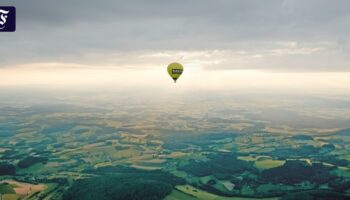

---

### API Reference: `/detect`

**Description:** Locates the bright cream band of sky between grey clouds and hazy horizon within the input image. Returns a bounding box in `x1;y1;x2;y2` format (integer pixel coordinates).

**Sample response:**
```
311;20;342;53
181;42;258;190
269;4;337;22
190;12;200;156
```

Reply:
0;58;350;94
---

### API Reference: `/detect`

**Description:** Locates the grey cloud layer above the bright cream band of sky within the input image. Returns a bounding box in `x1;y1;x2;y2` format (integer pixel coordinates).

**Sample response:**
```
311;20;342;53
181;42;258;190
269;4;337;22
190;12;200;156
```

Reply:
0;0;350;71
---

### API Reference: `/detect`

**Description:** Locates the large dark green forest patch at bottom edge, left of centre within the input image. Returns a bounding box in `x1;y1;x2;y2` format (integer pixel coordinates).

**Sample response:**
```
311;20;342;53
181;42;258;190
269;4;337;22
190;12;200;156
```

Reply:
63;166;185;200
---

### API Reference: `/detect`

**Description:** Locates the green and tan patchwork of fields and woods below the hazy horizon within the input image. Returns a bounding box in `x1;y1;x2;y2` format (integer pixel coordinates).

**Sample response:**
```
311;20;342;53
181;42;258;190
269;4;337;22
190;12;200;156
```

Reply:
0;93;350;200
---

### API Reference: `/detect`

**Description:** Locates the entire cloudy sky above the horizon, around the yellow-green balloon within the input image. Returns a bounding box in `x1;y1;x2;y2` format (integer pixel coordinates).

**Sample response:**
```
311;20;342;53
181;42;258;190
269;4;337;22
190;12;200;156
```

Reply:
0;0;350;93
